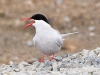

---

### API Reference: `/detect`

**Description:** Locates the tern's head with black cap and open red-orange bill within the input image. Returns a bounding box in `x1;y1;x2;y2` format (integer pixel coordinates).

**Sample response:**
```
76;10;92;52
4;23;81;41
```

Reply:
22;14;49;28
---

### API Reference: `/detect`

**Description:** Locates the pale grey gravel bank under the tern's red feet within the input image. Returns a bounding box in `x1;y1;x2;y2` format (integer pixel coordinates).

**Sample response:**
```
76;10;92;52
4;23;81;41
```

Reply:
0;47;100;75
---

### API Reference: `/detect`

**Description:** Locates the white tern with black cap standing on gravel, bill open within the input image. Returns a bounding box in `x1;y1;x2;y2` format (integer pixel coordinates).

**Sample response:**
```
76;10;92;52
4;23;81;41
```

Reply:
22;14;77;62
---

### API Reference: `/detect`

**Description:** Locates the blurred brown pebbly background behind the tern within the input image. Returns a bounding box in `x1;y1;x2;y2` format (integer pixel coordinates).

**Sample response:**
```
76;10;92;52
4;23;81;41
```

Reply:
0;0;100;64
